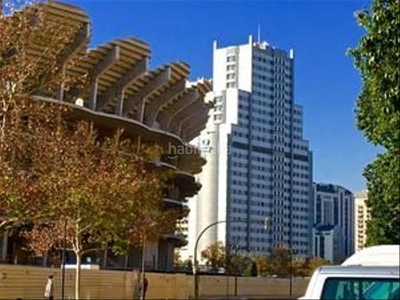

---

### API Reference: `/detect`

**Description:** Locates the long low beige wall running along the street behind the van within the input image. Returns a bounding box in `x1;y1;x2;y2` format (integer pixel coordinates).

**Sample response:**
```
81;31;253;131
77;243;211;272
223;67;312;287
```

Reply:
0;265;308;299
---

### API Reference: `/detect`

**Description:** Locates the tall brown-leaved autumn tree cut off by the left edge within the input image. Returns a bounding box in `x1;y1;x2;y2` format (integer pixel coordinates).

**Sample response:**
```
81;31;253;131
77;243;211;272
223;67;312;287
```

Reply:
0;0;83;237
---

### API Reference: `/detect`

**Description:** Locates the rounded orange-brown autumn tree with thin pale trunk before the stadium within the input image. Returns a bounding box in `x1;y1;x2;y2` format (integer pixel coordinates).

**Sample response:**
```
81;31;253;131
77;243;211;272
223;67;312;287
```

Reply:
24;119;171;299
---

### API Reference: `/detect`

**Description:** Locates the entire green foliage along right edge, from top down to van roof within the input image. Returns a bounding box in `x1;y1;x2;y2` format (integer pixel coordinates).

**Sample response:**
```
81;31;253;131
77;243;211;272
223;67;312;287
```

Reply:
350;0;400;245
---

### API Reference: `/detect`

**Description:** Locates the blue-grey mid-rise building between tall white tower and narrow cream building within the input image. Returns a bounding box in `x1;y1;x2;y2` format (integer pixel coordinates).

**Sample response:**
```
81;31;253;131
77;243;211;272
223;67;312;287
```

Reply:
313;183;354;262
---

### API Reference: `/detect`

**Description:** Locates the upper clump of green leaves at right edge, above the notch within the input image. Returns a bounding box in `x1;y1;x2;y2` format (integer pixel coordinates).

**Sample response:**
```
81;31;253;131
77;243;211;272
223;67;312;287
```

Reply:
350;0;400;149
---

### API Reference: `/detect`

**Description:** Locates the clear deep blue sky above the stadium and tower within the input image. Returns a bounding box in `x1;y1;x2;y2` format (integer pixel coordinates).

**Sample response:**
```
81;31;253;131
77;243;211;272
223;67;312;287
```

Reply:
68;0;378;191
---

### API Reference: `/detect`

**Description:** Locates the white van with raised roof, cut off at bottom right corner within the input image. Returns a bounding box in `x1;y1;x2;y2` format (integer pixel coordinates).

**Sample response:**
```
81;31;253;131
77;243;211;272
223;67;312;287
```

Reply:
300;245;400;300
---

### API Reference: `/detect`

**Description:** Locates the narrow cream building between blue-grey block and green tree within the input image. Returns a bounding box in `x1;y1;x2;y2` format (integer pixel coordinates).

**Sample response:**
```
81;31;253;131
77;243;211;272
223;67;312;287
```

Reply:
354;191;370;252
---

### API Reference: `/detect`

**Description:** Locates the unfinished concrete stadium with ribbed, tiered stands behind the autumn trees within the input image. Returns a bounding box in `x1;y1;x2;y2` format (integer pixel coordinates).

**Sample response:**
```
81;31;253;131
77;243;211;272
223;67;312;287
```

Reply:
0;2;211;270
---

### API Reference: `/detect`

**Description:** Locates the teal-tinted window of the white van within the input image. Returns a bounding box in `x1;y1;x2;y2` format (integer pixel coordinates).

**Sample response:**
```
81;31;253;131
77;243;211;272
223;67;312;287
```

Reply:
321;278;400;300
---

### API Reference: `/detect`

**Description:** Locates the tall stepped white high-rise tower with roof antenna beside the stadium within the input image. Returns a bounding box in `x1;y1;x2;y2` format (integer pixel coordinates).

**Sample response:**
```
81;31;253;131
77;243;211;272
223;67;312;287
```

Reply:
183;36;313;257
